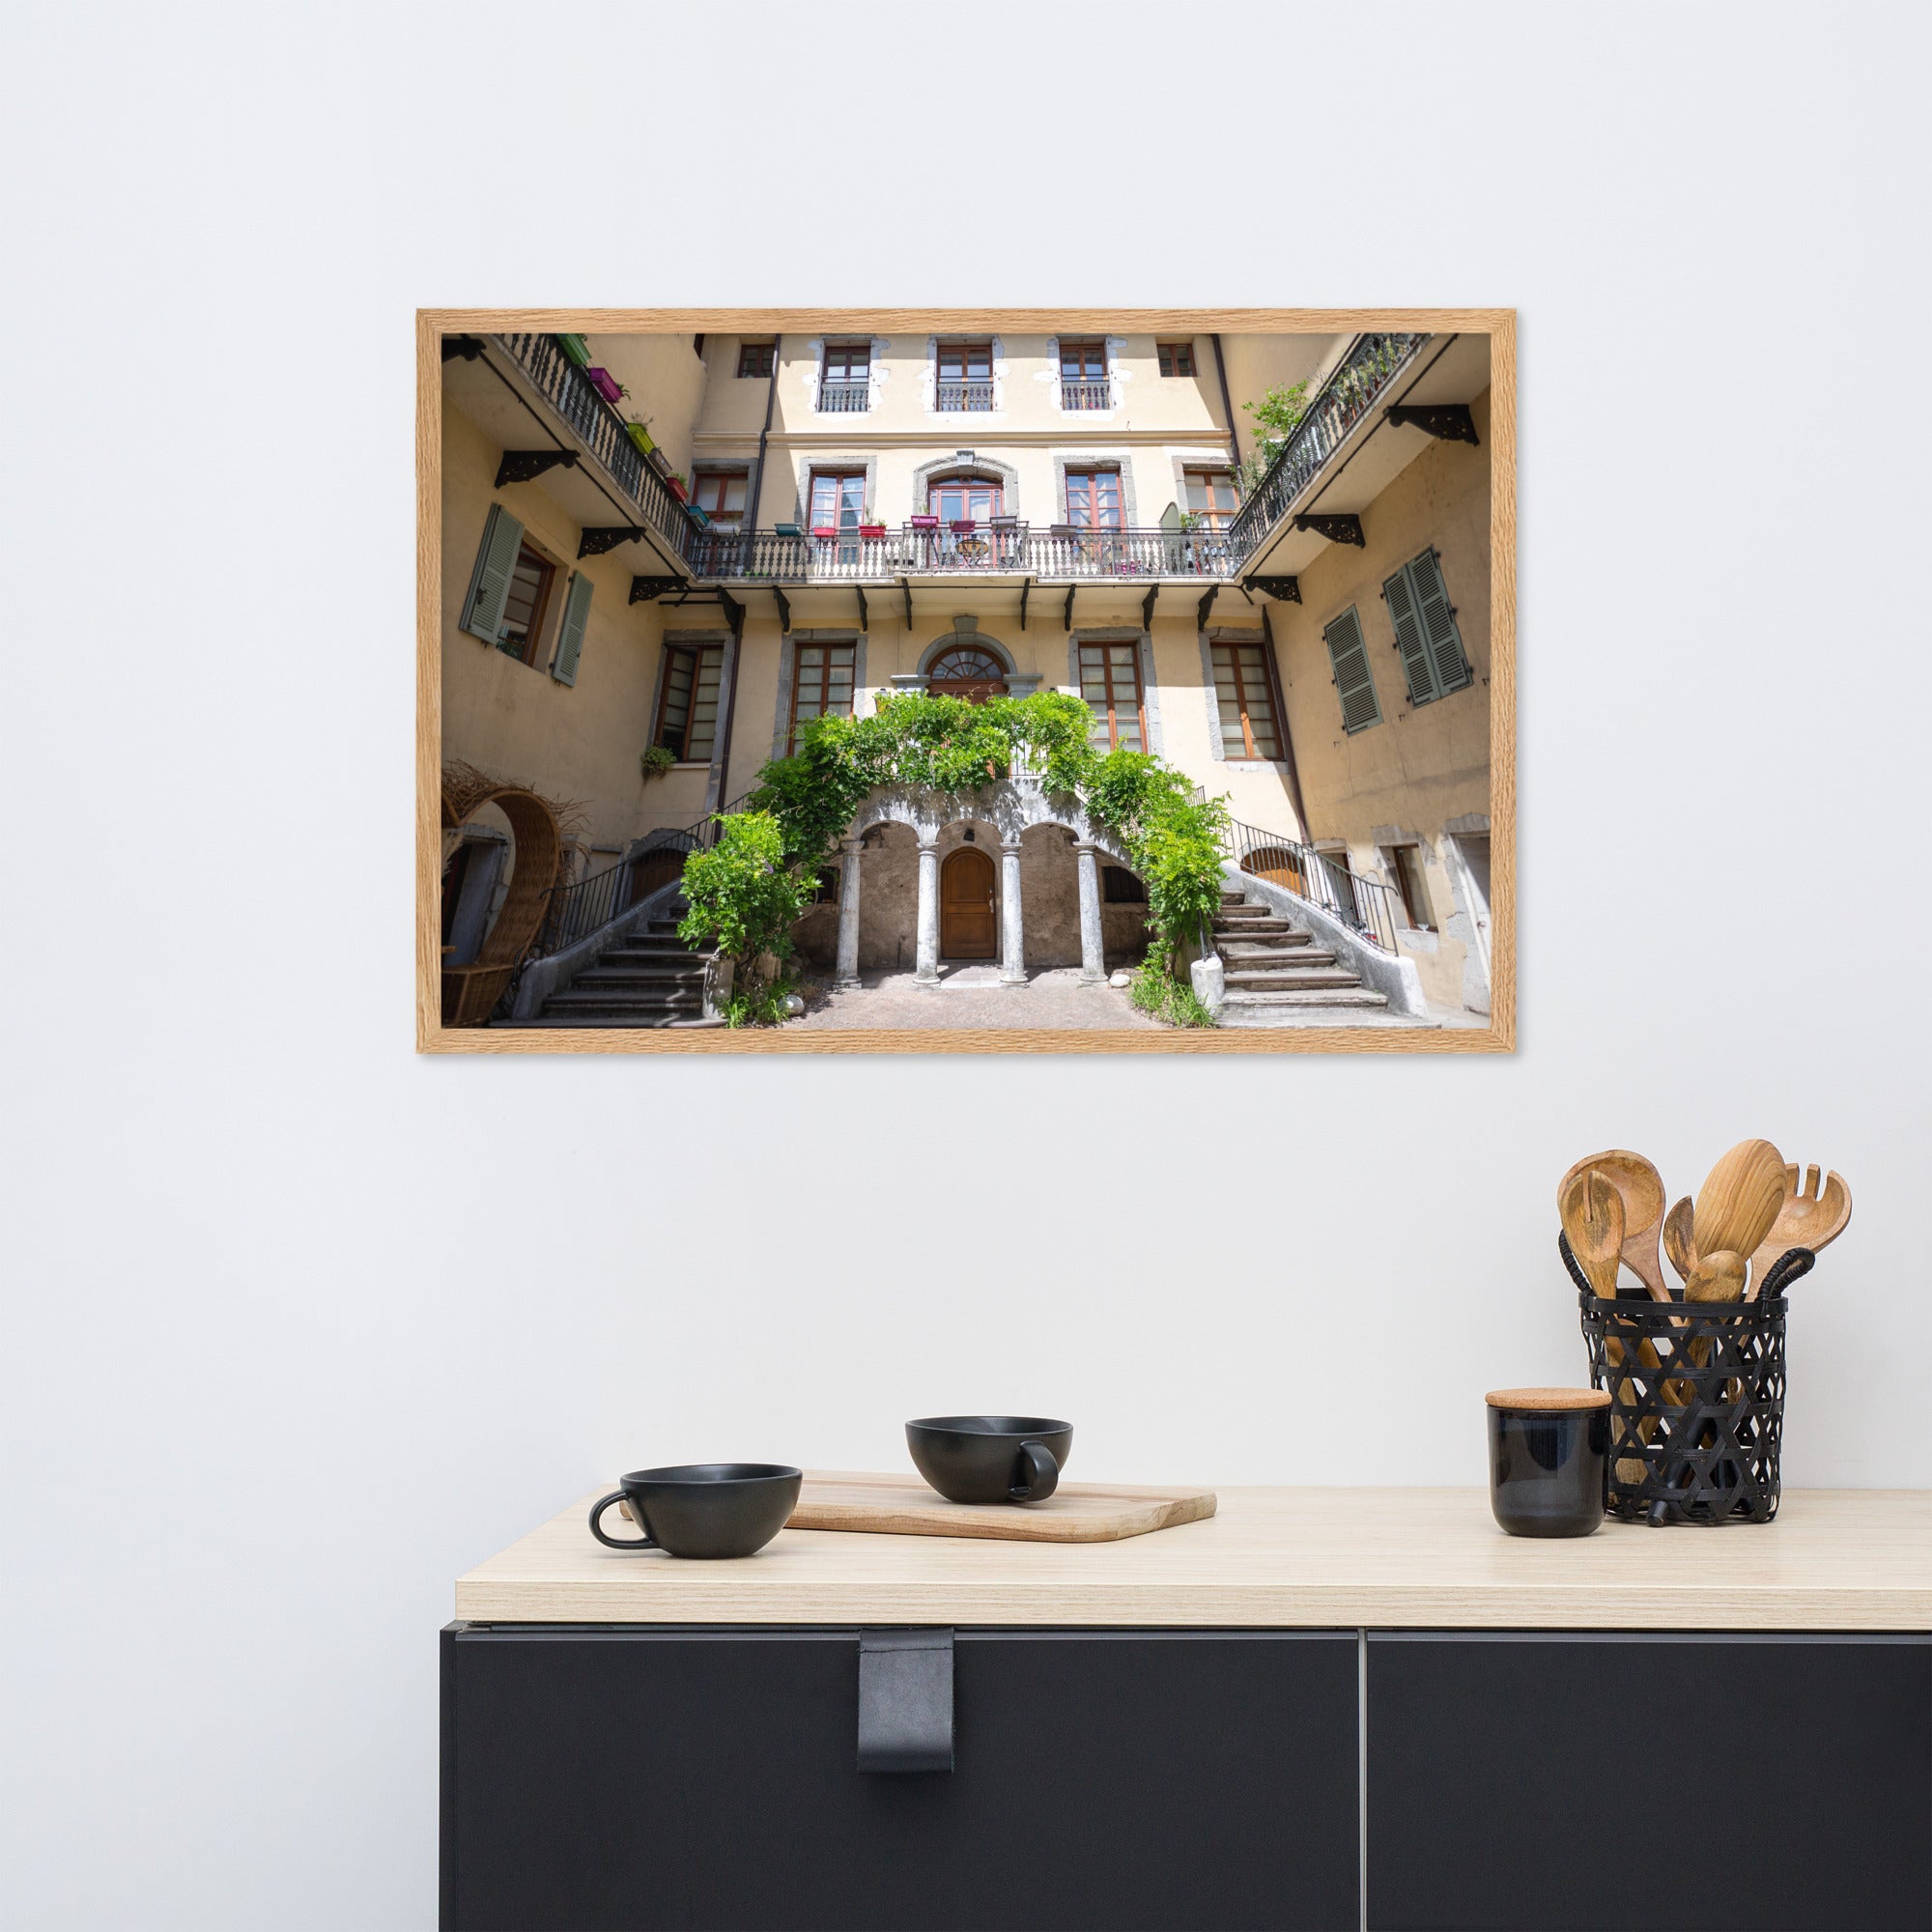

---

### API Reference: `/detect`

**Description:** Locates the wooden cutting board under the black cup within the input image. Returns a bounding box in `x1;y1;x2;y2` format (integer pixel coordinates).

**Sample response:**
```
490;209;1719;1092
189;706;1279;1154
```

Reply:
784;1470;1215;1544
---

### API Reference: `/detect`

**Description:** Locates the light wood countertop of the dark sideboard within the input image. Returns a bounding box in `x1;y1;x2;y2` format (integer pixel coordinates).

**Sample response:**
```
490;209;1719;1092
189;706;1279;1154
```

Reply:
456;1490;1932;1631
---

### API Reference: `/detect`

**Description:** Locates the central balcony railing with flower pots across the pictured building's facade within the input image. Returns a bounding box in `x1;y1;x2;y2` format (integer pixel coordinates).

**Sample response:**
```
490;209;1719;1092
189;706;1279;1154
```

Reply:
686;524;1246;585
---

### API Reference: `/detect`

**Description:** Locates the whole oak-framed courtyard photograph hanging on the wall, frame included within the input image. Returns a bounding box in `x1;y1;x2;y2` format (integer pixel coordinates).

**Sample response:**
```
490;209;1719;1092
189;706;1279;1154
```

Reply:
417;309;1515;1053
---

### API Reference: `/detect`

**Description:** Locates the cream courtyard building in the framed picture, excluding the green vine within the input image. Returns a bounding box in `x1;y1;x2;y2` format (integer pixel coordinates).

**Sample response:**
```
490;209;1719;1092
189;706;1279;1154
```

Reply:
440;325;1492;1028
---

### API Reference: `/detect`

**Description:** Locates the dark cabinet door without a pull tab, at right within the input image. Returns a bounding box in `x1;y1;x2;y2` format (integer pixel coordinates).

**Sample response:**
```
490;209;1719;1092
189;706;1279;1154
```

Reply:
1368;1631;1932;1932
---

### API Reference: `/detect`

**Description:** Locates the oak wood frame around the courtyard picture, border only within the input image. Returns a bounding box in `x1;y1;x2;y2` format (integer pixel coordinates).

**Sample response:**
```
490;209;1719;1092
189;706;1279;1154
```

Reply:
415;309;1517;1055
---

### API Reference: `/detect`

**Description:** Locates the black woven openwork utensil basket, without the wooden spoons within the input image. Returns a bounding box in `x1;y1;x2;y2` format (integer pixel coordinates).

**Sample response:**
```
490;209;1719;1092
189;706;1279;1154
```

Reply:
1557;1235;1816;1524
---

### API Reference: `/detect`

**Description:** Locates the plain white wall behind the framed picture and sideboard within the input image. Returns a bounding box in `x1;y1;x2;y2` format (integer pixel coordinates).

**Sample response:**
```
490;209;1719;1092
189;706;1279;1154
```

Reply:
11;0;1932;1932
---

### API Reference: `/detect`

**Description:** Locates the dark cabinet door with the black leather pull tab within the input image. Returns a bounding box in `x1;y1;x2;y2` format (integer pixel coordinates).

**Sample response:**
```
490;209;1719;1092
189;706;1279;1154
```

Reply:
442;1625;1360;1932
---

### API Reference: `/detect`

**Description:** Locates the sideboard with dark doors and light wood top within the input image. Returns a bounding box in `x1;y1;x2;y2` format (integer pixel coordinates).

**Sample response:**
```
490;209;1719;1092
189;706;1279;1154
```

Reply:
442;1490;1932;1932
